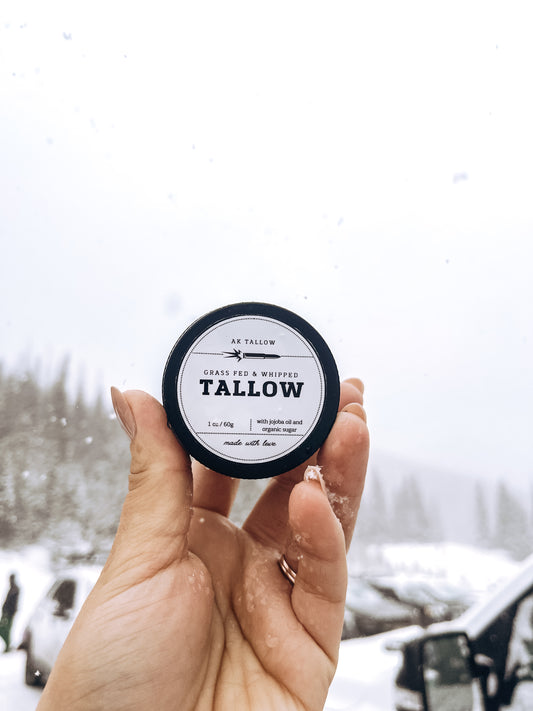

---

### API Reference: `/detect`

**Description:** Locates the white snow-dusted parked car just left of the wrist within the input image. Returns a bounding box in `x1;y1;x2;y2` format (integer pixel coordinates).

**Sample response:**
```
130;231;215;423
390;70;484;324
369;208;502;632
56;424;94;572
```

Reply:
21;566;100;686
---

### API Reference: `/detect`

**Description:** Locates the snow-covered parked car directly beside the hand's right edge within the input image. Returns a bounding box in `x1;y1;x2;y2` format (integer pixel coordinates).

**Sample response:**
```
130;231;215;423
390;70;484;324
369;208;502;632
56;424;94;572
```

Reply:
342;577;417;639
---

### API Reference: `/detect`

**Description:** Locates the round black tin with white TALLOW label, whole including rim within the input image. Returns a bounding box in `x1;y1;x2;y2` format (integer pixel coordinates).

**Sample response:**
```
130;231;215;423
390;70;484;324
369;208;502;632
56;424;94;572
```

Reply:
163;302;339;479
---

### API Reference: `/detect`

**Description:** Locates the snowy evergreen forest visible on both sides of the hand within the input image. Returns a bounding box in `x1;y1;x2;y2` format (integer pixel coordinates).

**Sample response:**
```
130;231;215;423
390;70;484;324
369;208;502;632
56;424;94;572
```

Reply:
0;360;533;559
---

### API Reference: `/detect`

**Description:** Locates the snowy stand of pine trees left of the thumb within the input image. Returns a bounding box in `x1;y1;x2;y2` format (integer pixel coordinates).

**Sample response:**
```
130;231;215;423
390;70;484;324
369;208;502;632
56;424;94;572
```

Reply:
0;360;129;547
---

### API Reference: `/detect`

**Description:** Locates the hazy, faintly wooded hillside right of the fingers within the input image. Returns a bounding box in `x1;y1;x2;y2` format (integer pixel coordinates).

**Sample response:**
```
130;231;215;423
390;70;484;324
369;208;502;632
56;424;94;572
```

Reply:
358;451;533;557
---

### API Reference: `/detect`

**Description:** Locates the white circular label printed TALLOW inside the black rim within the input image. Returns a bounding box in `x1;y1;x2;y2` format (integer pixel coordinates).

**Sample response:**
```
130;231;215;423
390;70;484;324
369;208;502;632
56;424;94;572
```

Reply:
176;316;325;464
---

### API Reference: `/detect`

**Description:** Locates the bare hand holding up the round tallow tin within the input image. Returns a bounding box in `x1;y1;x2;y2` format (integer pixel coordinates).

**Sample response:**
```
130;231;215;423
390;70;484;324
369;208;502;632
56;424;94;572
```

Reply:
38;379;368;711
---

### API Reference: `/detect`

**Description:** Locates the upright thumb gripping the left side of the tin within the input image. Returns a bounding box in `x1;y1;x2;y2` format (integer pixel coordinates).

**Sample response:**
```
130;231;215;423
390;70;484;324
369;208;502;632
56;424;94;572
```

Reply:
104;388;192;575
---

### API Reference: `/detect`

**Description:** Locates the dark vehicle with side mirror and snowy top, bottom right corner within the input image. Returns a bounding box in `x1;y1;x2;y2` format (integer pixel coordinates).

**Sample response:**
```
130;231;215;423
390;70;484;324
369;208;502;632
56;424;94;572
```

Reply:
395;556;533;711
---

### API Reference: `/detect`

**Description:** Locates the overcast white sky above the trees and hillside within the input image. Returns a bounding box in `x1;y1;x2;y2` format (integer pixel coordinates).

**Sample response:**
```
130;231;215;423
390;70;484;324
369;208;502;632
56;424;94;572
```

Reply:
0;0;533;485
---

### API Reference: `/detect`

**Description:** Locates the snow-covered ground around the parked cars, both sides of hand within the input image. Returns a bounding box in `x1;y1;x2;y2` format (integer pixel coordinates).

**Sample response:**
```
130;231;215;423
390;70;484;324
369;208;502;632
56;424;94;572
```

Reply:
0;544;518;711
